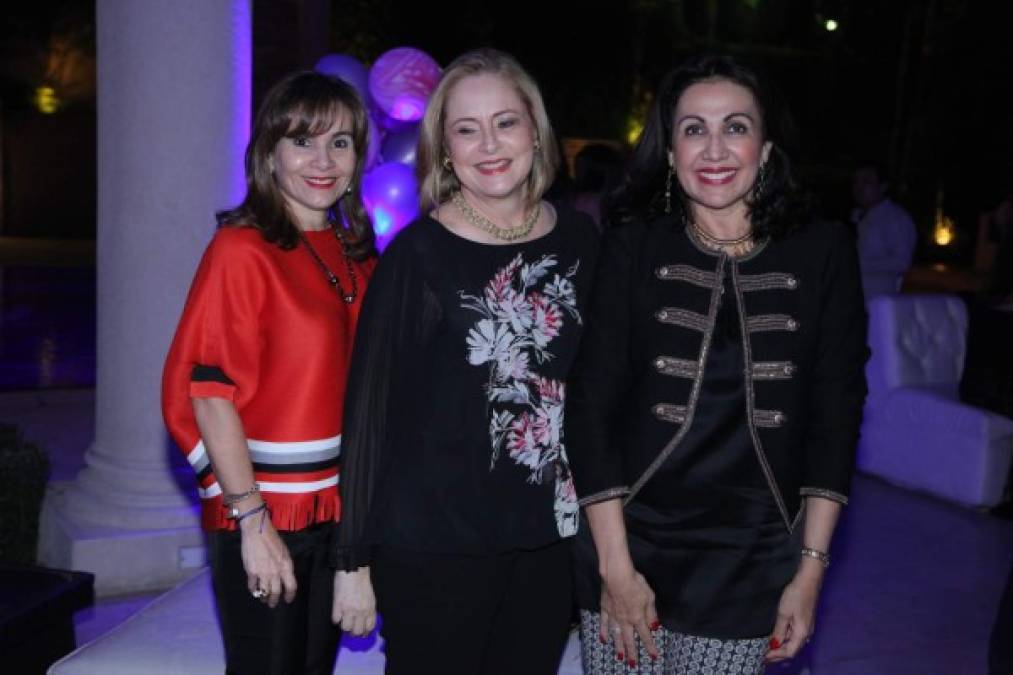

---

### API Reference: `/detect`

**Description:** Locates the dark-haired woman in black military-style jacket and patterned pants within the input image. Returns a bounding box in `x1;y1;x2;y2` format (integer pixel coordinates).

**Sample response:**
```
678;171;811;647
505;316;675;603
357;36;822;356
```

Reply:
566;56;867;674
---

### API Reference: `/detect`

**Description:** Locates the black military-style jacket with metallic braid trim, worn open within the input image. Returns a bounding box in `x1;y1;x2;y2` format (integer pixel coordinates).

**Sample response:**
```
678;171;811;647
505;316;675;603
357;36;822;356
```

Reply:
565;217;868;530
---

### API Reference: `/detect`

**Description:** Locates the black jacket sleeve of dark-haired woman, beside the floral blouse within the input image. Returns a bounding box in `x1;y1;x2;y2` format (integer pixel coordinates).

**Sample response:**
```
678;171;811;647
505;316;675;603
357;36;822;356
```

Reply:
565;226;633;506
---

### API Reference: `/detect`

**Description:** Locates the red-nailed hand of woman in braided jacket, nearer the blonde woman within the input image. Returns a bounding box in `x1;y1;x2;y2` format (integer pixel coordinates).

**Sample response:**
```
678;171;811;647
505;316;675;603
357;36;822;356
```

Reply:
602;564;660;666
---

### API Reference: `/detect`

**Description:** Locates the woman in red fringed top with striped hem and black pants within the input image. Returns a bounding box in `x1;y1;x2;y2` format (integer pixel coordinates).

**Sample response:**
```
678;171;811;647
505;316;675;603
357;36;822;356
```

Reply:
162;72;375;674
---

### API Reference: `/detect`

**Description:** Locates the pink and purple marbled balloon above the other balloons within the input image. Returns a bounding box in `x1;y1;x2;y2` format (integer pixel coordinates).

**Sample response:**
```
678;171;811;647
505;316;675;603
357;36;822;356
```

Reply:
370;47;440;122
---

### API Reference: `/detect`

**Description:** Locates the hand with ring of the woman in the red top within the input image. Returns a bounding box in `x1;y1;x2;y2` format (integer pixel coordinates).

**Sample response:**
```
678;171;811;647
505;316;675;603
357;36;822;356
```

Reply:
239;512;296;607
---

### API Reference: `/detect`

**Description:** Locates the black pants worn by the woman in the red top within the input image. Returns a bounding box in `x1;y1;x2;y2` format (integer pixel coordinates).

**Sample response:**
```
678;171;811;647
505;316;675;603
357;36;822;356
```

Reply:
208;523;340;675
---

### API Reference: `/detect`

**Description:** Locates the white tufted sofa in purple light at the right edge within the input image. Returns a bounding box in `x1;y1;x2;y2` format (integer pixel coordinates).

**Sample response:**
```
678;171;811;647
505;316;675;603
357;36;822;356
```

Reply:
858;295;1013;508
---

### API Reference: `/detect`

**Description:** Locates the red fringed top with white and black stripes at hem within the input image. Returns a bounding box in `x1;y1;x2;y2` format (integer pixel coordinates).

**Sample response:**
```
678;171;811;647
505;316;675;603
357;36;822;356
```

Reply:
162;227;375;530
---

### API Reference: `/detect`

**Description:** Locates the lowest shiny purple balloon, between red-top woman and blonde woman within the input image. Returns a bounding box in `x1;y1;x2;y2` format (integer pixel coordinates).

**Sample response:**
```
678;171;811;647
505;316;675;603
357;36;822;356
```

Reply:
363;162;418;250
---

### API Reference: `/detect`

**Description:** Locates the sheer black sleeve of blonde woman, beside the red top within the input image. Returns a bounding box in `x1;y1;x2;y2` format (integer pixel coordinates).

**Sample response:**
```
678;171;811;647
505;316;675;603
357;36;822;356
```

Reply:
331;225;440;571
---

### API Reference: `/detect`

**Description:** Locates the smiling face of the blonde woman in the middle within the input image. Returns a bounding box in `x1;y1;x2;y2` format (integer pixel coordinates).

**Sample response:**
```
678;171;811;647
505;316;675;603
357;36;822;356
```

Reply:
444;73;535;202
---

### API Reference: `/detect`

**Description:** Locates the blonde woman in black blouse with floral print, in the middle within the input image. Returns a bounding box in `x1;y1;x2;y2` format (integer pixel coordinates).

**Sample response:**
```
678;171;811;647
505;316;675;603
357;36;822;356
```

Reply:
334;50;598;675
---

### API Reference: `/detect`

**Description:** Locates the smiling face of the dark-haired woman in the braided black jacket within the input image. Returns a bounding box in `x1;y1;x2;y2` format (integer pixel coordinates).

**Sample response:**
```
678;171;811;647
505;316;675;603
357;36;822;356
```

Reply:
669;80;771;217
